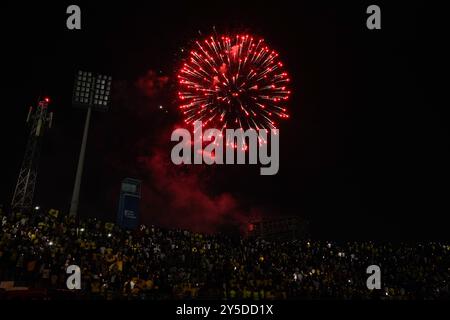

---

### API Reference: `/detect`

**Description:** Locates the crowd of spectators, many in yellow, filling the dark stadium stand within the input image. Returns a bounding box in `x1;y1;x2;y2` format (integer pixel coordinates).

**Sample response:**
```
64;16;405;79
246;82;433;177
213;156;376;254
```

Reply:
0;210;450;300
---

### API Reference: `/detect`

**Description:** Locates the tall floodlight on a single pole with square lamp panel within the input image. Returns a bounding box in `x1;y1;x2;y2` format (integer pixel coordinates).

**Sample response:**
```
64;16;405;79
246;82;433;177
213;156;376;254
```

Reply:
69;71;112;216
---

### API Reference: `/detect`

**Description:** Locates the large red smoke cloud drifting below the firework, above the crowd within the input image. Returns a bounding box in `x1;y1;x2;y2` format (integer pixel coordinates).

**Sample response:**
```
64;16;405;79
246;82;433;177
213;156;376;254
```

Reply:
138;145;246;232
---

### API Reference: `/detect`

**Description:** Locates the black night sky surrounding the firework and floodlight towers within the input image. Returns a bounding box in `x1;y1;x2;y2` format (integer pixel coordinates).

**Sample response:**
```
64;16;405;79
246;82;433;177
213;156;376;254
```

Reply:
0;1;450;239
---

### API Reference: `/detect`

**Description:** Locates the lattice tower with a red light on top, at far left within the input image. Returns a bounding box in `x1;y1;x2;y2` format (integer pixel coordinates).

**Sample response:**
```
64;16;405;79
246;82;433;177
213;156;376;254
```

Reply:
11;97;53;211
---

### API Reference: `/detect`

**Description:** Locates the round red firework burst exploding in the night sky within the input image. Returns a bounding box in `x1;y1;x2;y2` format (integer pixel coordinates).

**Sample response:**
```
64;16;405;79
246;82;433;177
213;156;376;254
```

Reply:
178;35;290;130
